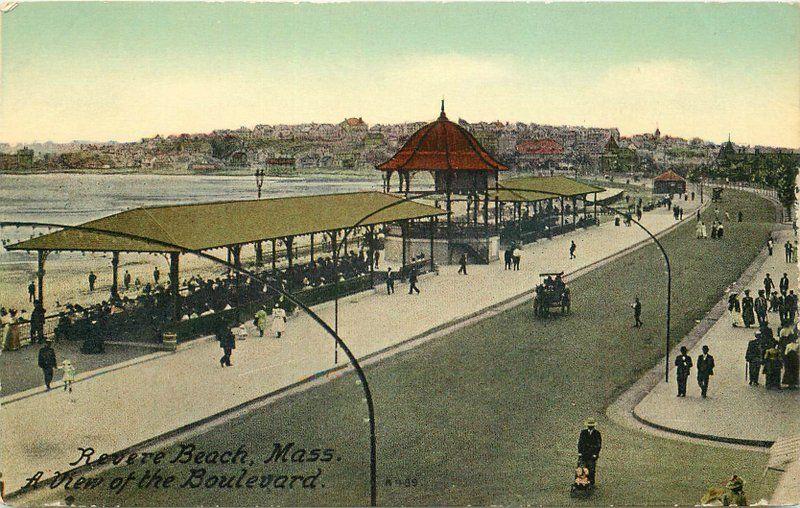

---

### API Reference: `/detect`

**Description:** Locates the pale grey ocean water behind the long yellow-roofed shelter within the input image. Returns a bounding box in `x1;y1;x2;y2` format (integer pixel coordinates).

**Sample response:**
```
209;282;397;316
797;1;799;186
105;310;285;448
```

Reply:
0;171;381;266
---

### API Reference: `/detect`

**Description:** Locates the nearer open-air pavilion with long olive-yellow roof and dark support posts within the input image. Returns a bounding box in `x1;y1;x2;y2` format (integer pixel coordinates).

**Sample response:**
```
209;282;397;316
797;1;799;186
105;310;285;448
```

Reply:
6;192;446;330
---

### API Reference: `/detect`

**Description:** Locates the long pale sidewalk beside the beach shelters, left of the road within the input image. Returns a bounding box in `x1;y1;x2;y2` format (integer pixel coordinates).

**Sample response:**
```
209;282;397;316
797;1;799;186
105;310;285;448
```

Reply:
2;193;699;492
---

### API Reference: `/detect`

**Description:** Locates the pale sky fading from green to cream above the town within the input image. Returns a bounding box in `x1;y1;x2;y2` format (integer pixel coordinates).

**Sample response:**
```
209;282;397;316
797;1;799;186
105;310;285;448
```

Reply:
0;2;800;148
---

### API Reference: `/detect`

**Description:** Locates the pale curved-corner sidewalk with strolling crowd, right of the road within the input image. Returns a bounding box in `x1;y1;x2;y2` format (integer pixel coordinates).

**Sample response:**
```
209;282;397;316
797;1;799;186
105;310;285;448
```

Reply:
633;229;800;446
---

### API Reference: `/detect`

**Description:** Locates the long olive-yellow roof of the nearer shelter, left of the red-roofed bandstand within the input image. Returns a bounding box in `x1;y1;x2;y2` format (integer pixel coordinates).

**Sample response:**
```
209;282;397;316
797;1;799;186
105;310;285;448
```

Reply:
6;191;446;252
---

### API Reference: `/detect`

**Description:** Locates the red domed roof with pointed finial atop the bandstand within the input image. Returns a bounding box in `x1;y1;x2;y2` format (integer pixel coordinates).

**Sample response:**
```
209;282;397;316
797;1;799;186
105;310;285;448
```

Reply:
377;101;508;171
